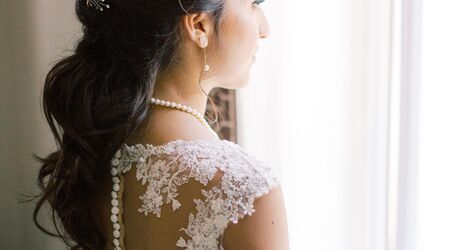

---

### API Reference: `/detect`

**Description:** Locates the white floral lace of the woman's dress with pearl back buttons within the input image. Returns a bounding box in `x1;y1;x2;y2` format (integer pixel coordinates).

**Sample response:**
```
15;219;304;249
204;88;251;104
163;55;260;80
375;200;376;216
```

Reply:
112;139;280;250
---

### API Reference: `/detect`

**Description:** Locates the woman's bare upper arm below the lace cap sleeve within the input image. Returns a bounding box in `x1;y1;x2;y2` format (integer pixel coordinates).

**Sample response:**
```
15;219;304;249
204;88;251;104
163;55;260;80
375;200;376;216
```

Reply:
224;185;289;250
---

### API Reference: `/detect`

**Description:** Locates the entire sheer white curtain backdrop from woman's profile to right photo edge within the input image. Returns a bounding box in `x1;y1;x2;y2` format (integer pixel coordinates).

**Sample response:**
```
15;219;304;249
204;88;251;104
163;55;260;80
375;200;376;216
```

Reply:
238;0;450;250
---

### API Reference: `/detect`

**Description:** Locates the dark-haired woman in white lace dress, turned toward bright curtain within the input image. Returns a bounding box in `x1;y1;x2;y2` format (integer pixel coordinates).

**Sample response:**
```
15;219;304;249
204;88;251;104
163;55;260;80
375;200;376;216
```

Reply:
34;0;288;250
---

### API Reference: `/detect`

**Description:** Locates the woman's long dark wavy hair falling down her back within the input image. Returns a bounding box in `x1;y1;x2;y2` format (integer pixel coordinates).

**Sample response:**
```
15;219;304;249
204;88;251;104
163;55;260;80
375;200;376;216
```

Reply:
22;0;224;250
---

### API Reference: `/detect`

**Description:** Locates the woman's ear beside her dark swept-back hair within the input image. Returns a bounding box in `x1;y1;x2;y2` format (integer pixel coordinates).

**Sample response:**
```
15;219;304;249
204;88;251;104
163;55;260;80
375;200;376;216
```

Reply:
181;13;213;47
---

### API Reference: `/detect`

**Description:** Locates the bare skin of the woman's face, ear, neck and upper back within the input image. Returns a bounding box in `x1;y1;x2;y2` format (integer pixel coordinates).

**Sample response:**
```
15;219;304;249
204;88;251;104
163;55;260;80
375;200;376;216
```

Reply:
127;0;270;145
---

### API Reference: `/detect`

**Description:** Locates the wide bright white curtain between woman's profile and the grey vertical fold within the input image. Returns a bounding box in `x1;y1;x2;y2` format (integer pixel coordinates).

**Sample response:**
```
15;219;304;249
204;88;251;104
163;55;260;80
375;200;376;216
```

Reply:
238;0;398;250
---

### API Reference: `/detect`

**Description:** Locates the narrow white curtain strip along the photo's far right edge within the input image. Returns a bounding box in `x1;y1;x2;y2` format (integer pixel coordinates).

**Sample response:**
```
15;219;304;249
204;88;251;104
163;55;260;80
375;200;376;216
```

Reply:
416;0;450;250
